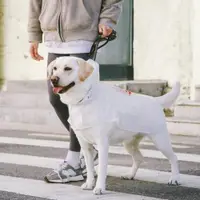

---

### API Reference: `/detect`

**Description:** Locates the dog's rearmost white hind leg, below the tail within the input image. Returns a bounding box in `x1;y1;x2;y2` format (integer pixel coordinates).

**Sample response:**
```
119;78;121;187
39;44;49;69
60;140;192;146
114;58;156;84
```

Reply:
150;128;180;185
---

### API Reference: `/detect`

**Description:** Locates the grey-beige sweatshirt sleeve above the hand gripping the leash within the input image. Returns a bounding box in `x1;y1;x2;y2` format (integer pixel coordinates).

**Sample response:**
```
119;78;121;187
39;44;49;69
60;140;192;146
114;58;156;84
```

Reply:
99;0;123;28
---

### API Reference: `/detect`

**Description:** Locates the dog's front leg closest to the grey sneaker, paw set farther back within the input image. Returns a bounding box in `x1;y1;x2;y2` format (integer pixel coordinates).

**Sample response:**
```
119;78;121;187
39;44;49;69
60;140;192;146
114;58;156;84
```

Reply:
78;138;95;190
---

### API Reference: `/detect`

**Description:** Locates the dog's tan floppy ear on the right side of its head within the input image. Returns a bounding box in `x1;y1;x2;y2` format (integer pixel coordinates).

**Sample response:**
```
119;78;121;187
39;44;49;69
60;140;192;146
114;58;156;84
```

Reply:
77;59;94;82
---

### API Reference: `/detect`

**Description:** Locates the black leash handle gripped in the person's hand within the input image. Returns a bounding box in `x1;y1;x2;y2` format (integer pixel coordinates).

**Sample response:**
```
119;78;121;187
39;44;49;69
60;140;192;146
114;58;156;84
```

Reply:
89;30;117;60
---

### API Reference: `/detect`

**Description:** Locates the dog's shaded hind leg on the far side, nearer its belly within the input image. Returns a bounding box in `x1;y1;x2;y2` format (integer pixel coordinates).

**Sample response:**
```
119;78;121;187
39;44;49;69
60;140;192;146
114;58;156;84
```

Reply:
122;135;143;180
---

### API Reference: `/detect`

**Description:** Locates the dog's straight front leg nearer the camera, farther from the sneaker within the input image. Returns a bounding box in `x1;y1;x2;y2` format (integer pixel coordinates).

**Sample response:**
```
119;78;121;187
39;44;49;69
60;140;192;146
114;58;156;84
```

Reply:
93;138;109;195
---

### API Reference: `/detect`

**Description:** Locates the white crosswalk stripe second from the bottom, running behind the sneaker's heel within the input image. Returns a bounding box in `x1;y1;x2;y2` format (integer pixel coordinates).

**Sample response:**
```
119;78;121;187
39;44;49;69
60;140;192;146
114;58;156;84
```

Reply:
0;153;200;189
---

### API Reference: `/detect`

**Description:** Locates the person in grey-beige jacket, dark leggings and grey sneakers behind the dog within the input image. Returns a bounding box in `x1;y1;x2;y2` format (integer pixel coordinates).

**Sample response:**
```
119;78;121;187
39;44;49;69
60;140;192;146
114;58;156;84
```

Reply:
28;0;123;183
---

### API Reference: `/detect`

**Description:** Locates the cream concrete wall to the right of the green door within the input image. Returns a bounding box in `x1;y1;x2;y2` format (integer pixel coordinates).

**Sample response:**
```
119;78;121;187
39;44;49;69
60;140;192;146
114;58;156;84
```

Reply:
134;0;200;98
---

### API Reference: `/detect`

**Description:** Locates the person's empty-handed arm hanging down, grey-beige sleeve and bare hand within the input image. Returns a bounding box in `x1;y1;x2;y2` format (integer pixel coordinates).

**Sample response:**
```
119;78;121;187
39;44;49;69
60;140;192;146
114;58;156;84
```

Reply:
28;0;44;61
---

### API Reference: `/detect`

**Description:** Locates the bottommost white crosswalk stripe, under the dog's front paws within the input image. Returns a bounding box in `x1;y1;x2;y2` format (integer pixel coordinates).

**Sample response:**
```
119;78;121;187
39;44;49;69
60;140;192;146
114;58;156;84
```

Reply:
0;176;166;200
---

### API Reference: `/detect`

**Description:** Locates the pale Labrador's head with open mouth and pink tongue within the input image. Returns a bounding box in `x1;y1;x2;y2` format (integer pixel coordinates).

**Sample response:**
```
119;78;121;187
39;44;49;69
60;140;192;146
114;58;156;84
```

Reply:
48;57;94;94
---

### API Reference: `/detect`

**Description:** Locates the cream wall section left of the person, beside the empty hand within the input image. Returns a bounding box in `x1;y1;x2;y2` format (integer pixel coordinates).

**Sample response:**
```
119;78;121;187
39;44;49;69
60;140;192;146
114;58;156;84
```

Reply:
4;0;46;80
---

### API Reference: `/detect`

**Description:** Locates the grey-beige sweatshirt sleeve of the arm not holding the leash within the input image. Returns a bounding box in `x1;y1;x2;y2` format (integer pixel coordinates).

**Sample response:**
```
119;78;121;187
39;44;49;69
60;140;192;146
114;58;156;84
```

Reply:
28;0;42;42
